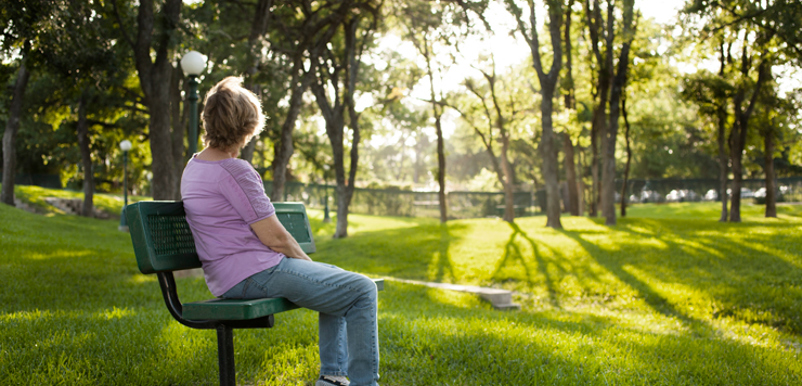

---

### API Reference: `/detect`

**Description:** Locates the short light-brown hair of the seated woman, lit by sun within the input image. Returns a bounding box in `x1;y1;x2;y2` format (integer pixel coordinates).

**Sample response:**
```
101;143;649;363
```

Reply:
201;76;265;151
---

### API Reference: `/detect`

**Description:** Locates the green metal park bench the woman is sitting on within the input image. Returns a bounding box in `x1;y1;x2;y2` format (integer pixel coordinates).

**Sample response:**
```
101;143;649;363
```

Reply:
125;201;384;386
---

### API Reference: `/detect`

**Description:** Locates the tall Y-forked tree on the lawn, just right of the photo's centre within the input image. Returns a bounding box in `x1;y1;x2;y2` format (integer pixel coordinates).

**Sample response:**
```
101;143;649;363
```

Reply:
506;0;563;229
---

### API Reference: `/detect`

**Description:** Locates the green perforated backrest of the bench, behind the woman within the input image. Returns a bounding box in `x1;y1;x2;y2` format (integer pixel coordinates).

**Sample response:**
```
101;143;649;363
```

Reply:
125;201;316;273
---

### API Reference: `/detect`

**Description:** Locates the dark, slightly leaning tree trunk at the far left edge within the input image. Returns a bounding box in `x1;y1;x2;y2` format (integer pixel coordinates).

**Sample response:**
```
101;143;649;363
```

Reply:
0;60;30;206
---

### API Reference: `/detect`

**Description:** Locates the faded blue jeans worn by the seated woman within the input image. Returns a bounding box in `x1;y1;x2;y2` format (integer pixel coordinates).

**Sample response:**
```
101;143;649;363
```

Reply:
223;257;379;386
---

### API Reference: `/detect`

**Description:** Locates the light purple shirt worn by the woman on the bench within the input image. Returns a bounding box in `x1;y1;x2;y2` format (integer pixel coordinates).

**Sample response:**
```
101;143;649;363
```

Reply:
181;158;284;296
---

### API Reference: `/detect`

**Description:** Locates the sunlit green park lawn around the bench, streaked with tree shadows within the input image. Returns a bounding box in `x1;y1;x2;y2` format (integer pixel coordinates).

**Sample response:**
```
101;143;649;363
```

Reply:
0;193;802;385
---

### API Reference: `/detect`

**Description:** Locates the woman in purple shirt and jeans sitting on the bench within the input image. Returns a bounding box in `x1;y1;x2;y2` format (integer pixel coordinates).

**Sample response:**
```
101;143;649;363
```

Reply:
181;77;379;386
